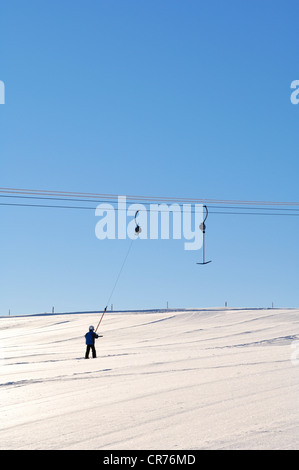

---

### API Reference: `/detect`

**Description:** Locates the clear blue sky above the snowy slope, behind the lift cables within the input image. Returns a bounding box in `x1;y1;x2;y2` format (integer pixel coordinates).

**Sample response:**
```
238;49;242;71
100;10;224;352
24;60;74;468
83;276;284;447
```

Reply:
0;0;299;314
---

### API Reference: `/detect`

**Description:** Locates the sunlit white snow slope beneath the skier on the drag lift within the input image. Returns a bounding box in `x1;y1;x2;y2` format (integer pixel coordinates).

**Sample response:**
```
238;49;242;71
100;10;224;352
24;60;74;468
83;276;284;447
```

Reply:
0;309;299;450
